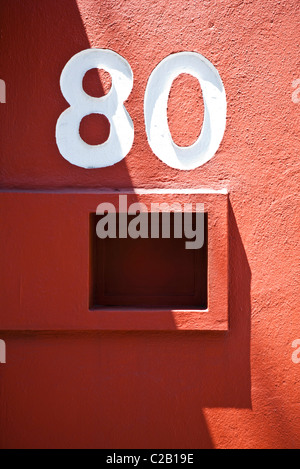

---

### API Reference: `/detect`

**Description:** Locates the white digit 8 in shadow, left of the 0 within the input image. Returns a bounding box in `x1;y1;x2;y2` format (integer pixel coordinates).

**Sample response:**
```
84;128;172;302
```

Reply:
56;49;134;168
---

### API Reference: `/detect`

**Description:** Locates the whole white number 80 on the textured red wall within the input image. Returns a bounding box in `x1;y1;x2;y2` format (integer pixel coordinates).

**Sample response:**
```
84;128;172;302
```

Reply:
56;49;227;170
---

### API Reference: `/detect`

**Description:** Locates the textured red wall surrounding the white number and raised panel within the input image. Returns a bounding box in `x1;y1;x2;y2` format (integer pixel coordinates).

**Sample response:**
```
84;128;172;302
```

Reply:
0;0;300;448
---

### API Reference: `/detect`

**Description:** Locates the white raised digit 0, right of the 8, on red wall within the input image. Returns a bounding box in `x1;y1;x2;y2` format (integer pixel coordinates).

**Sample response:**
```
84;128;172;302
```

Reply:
145;52;227;170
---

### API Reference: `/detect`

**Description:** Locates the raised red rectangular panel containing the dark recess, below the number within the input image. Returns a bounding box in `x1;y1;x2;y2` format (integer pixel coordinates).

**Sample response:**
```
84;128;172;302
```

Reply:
0;188;227;332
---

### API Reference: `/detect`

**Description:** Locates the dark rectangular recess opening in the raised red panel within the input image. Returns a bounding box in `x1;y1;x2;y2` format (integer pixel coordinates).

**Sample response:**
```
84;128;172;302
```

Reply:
90;213;208;308
